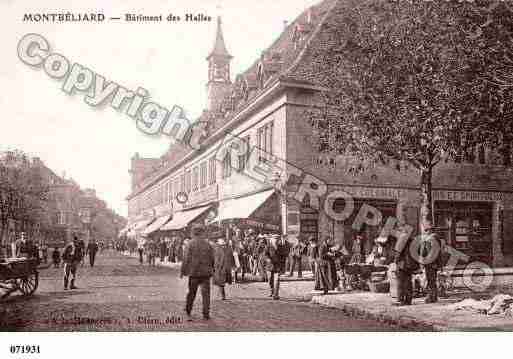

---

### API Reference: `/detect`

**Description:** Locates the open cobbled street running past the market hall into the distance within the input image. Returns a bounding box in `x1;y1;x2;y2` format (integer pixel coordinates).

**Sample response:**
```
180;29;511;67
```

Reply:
0;252;397;331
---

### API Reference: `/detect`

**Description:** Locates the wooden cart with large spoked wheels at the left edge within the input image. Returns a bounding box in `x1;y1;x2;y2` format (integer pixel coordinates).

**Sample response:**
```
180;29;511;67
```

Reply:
0;258;39;299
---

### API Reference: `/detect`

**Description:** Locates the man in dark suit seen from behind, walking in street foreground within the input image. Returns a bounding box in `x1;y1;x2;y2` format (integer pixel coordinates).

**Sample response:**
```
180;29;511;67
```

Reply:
180;225;214;320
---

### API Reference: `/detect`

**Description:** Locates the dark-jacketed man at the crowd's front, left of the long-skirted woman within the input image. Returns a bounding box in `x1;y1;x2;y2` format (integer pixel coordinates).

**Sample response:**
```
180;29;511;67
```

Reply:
267;235;290;300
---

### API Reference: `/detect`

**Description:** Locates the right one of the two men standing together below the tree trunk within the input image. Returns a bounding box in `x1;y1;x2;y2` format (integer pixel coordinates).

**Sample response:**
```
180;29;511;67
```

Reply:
420;222;442;303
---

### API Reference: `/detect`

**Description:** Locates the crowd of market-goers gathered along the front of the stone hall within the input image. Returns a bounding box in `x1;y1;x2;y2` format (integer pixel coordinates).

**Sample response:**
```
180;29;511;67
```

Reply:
176;224;442;318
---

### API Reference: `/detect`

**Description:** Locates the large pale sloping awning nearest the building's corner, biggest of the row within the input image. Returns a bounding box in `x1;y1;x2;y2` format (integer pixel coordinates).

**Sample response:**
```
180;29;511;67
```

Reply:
216;189;274;222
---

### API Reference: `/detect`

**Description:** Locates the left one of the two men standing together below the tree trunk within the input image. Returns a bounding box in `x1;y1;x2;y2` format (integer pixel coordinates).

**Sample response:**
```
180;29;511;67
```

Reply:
394;234;419;305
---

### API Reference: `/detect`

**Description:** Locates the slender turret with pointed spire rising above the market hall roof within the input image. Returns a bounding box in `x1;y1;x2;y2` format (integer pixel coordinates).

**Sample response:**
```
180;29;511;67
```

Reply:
207;17;233;111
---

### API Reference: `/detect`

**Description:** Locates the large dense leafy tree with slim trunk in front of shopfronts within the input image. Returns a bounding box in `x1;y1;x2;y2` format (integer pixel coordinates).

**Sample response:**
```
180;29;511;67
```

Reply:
311;0;513;233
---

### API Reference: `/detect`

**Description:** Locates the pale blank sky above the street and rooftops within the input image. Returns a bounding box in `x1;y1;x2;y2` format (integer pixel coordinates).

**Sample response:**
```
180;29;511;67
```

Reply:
0;0;319;216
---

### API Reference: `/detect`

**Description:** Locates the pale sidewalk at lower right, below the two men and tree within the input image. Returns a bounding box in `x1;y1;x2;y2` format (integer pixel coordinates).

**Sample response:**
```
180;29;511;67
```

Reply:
312;286;513;331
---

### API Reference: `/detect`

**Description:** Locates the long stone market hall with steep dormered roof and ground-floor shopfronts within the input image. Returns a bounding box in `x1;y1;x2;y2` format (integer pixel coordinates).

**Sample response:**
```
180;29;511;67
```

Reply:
128;0;513;266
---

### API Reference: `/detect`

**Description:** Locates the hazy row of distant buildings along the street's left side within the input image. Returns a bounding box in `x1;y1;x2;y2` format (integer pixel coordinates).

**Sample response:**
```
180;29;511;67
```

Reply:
1;157;126;247
